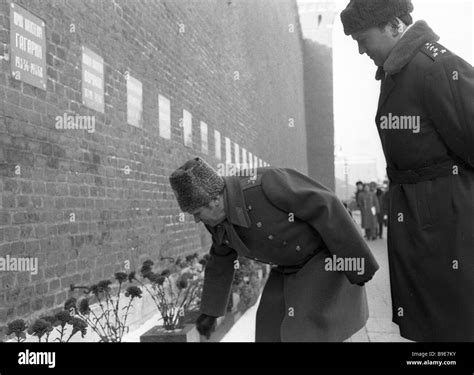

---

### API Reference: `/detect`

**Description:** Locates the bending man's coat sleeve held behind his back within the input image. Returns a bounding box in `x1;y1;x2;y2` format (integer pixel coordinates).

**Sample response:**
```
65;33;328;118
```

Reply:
262;168;379;284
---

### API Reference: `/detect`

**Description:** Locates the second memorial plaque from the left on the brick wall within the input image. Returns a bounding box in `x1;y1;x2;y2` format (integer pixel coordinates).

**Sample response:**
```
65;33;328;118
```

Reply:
82;47;104;113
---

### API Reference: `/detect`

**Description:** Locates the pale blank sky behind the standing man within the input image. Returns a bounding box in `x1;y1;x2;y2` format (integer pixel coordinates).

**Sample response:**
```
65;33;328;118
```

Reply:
298;0;474;180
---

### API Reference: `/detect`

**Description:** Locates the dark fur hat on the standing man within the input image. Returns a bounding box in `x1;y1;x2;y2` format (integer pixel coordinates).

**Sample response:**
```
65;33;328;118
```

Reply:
341;0;413;35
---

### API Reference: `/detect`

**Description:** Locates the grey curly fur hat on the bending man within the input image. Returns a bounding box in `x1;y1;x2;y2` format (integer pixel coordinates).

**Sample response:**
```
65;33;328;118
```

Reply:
169;157;225;212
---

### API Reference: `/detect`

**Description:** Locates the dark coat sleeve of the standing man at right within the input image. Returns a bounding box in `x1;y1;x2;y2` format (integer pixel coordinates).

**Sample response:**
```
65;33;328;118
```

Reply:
424;54;474;167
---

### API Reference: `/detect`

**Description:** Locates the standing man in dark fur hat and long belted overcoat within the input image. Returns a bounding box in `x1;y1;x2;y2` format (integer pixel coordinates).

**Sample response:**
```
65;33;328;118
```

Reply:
341;0;474;341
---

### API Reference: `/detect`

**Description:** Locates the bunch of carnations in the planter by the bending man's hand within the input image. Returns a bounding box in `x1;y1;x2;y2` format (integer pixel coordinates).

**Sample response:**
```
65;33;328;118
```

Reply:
133;254;207;331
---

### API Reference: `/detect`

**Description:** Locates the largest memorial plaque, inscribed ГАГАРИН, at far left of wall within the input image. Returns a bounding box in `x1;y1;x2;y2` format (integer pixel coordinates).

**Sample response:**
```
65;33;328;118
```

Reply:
10;4;47;90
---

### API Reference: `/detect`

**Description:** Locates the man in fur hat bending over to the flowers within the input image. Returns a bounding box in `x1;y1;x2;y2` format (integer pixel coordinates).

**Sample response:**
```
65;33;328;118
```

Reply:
170;158;378;342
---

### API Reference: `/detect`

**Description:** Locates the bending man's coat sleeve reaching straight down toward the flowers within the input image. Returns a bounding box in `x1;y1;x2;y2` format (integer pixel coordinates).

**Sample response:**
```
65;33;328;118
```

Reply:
200;227;237;317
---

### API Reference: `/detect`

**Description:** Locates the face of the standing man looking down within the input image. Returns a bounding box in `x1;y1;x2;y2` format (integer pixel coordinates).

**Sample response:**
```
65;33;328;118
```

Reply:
352;25;397;66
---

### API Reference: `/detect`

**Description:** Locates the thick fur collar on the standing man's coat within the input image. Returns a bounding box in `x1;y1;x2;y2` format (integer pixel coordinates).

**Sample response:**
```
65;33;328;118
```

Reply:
375;20;439;80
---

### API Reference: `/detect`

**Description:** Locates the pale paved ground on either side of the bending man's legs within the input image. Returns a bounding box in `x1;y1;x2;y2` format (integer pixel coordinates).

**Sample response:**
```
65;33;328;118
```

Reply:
221;231;408;342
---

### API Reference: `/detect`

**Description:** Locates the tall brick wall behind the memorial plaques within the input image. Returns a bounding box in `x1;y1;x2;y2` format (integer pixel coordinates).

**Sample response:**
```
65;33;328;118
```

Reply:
0;0;308;334
